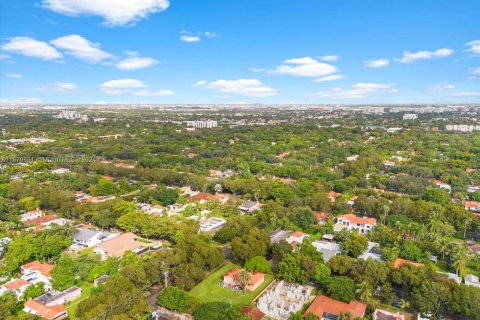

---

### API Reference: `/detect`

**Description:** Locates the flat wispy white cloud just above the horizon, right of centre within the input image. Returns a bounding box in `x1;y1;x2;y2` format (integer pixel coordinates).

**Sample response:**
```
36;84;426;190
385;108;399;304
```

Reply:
313;82;399;99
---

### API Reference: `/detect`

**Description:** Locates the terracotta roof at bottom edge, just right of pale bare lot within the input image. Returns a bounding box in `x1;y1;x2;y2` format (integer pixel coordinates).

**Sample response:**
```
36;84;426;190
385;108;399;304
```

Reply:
305;296;367;319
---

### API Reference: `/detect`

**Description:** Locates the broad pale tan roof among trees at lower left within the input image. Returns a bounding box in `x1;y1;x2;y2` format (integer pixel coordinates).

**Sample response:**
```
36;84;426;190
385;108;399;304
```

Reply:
94;232;145;259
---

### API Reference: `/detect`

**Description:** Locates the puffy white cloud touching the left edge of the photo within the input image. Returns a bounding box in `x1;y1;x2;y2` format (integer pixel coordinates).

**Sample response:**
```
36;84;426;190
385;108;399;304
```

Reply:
1;37;62;60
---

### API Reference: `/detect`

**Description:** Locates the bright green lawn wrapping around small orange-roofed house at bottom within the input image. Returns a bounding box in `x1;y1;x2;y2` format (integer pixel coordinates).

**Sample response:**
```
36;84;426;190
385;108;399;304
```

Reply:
189;263;274;306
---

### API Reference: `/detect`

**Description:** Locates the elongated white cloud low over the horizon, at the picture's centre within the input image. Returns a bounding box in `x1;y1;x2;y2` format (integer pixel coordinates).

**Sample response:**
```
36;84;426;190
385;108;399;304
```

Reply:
193;79;277;97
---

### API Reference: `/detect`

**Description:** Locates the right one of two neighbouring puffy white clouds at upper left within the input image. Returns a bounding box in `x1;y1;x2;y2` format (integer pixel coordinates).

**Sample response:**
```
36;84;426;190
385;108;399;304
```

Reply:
50;34;113;63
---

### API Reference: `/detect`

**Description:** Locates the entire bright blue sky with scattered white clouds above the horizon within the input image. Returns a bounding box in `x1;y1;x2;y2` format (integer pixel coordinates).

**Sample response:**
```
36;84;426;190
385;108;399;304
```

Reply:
0;0;480;104
